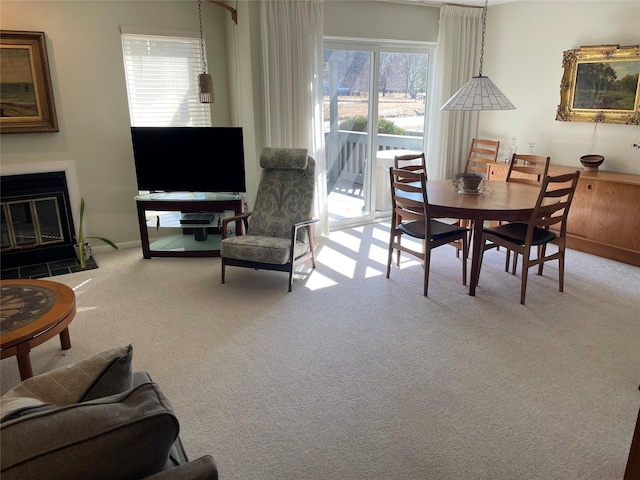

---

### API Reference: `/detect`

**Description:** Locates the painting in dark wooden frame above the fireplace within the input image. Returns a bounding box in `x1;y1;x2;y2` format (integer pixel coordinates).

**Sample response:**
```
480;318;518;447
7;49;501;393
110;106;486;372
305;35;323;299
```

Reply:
0;30;59;133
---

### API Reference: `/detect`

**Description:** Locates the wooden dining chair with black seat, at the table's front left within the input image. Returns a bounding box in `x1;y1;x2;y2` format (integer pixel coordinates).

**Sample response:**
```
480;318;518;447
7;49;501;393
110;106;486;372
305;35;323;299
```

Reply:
387;167;469;297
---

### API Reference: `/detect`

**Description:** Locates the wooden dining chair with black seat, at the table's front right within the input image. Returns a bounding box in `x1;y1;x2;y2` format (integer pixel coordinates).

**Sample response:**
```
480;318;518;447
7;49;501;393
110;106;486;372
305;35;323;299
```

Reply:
478;171;580;305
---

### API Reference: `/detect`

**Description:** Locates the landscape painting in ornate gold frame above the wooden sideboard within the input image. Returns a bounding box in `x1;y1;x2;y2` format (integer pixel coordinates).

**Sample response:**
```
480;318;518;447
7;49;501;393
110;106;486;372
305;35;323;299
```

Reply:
556;45;640;125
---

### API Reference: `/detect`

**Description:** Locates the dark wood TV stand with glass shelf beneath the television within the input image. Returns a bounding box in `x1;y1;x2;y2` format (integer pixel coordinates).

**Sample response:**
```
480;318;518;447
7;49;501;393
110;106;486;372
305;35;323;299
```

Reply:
135;192;245;258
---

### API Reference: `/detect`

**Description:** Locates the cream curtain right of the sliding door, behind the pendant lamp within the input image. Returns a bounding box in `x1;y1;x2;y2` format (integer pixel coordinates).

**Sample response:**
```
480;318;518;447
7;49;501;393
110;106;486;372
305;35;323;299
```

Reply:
427;5;482;179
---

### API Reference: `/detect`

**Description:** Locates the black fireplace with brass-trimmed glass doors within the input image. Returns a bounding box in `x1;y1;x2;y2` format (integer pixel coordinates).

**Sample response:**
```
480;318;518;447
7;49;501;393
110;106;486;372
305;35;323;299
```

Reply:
0;171;75;270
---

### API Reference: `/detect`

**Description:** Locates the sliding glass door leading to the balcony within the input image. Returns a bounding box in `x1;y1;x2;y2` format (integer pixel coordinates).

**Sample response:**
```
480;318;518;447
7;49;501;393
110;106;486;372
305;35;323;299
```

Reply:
323;41;430;228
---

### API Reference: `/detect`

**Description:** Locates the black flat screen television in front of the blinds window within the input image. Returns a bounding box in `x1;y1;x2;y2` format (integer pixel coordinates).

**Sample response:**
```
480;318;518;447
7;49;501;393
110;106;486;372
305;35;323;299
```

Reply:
131;127;246;193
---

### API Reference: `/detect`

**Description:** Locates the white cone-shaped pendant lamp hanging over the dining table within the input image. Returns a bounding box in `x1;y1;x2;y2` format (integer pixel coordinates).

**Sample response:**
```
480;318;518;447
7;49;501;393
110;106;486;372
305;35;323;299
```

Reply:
440;0;516;111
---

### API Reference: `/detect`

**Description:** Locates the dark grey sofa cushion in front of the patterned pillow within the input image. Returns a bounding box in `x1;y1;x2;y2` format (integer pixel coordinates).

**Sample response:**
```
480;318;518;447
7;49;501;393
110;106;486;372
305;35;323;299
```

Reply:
0;383;180;480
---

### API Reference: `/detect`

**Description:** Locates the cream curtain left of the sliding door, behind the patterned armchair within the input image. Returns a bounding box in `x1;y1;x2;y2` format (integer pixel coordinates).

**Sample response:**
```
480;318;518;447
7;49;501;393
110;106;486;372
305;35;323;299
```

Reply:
260;0;329;236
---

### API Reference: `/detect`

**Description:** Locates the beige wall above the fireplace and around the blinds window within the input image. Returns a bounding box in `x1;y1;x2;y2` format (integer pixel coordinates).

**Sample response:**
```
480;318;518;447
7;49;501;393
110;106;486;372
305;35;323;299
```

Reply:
0;0;231;248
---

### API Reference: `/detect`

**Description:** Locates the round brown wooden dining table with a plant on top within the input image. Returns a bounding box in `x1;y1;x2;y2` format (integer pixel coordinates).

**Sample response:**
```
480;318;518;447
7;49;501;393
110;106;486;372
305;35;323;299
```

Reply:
427;179;544;296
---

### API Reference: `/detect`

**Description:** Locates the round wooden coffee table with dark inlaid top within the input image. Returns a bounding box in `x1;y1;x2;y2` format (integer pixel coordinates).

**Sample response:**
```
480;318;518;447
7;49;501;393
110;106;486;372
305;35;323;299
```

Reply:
0;280;76;380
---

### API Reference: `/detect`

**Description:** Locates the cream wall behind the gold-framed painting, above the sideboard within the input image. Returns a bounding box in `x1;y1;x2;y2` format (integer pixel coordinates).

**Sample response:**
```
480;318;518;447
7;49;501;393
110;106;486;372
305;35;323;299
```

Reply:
480;0;640;174
